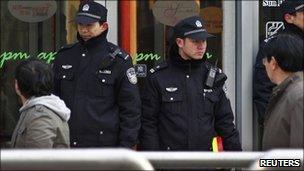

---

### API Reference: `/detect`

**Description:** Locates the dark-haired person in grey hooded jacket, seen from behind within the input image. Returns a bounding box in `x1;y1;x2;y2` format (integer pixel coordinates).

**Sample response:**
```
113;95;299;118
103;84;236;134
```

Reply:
11;59;71;148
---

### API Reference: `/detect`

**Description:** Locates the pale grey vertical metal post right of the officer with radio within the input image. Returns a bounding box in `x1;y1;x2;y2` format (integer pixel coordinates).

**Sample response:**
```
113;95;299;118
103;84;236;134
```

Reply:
236;1;259;150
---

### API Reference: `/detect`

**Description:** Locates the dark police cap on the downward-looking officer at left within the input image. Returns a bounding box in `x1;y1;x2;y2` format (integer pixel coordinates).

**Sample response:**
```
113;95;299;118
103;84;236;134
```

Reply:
75;0;108;24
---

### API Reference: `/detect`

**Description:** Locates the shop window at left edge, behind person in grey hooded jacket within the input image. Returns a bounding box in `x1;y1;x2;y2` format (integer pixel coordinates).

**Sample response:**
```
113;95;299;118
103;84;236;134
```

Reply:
0;0;80;146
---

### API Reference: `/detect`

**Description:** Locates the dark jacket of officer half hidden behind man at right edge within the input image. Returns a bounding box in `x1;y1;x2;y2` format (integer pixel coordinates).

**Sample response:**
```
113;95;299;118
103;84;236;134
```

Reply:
253;23;304;126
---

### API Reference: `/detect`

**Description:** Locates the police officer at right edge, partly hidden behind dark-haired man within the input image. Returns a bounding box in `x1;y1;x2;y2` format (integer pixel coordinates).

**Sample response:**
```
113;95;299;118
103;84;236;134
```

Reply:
253;0;304;146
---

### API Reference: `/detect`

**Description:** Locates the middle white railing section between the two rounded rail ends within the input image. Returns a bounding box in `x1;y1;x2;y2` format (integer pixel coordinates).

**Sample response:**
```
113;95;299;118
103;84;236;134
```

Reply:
141;152;264;169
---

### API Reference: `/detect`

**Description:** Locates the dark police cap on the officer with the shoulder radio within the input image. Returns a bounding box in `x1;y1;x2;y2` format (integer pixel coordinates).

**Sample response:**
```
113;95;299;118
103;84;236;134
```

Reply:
173;16;213;40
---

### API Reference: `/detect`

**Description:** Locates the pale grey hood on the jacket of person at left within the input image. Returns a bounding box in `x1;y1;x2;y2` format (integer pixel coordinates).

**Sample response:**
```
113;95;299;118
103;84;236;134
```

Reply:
19;94;71;121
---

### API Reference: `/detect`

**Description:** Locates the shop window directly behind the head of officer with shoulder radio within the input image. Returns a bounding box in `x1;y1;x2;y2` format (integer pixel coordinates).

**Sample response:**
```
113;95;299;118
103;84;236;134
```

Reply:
136;0;223;89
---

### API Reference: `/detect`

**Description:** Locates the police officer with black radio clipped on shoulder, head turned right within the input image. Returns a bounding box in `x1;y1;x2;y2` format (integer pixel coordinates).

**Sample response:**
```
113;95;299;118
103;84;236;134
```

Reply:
140;16;241;151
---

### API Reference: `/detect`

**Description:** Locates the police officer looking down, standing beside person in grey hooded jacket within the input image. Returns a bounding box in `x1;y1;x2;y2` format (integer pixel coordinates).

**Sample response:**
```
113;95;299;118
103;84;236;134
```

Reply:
53;1;141;148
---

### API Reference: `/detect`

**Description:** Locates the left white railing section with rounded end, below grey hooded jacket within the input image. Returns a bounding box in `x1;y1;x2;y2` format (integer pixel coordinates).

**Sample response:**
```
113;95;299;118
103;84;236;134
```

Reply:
1;149;154;170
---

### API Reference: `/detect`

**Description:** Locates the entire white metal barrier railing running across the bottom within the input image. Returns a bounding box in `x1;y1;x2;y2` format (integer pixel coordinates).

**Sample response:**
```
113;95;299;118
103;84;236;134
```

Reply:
1;149;303;170
